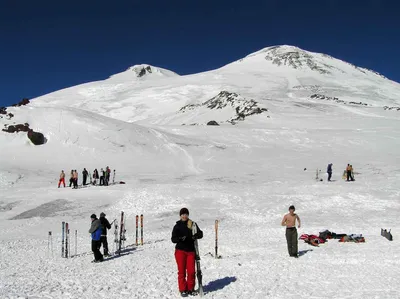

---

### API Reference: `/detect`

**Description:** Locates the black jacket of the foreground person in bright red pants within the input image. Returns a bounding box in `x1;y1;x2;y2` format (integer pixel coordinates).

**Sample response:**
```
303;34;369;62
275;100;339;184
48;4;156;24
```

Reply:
171;220;203;252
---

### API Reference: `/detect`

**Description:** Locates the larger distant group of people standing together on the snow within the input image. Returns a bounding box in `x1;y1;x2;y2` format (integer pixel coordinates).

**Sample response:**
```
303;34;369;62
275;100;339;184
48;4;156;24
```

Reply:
58;166;115;189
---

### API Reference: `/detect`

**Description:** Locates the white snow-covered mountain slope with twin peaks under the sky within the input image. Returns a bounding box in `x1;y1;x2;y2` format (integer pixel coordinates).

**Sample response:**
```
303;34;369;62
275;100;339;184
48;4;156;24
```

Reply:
0;46;400;299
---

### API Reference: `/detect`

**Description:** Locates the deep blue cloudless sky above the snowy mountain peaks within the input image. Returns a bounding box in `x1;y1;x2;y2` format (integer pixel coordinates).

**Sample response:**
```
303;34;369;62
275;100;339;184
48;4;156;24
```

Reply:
0;0;400;106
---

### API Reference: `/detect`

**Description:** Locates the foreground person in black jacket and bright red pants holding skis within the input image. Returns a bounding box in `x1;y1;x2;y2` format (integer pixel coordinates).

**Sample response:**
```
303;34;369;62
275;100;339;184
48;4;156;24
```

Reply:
171;208;203;297
